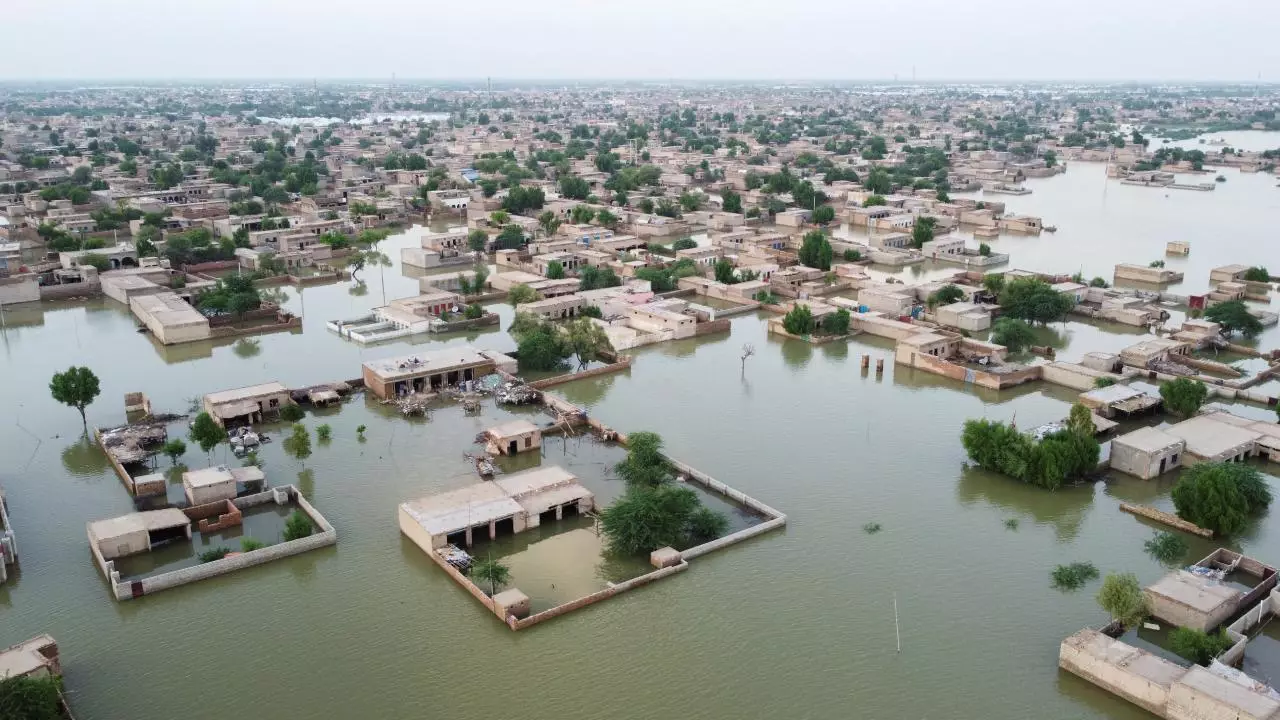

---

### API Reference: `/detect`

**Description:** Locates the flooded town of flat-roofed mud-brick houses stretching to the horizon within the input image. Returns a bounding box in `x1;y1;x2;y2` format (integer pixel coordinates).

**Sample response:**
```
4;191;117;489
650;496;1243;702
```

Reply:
0;83;1280;720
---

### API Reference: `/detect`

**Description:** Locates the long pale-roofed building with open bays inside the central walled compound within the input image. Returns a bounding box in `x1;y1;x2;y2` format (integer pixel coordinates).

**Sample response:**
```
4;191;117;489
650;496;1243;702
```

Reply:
398;466;595;552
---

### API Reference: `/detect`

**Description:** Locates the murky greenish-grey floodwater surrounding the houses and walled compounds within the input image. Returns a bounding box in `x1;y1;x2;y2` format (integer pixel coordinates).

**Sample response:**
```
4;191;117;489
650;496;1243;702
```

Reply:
0;142;1280;720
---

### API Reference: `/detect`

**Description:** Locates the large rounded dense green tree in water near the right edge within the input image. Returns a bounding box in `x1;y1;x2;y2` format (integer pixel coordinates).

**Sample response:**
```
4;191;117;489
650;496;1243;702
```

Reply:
1172;462;1271;537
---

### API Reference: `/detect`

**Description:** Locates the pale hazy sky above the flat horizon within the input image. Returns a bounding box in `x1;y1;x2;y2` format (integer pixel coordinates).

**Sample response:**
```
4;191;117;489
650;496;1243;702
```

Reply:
10;0;1280;82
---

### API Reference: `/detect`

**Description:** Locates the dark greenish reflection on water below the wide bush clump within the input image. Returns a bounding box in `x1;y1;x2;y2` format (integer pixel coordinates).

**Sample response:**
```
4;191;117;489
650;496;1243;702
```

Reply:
956;466;1094;542
